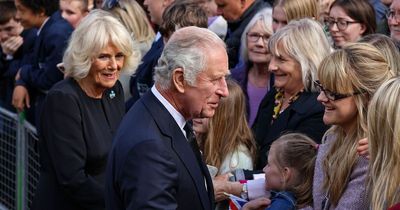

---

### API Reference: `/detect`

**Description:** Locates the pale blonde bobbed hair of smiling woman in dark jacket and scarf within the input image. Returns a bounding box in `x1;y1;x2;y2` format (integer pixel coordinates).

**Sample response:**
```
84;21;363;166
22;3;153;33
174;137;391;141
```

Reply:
268;18;331;92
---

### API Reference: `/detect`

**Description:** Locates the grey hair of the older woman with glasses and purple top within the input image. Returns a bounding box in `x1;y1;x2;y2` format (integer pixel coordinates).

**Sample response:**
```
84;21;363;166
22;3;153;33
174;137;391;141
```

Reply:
240;7;273;63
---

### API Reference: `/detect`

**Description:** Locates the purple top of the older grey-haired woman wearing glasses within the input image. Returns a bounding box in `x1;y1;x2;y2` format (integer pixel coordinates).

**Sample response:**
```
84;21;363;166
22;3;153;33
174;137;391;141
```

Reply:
247;81;269;126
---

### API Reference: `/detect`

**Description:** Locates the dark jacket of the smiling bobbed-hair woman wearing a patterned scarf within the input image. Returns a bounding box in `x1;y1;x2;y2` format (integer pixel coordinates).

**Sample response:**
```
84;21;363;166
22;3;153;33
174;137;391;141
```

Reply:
253;89;328;169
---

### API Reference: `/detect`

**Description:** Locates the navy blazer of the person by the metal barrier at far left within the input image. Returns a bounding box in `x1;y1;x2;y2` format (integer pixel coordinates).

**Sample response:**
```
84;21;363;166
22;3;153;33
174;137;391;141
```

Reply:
16;11;73;124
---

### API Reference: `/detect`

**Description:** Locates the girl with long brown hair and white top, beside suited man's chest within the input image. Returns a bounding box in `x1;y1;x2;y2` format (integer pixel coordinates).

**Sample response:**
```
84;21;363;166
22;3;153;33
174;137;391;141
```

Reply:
193;80;257;209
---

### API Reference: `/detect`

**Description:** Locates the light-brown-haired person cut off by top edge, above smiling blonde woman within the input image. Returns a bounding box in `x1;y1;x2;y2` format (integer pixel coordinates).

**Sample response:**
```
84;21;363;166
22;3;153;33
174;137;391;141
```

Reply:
272;0;319;32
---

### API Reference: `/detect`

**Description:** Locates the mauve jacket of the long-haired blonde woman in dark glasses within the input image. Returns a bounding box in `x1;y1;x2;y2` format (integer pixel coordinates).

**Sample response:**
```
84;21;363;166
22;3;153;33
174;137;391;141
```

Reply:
313;135;369;210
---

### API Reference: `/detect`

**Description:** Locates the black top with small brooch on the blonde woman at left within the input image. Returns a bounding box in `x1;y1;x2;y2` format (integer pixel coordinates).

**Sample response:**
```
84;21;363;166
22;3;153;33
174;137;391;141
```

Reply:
33;78;125;209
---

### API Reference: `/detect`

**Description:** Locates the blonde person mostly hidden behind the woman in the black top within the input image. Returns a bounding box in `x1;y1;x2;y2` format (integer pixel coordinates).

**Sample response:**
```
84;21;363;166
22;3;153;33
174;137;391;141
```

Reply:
103;0;155;101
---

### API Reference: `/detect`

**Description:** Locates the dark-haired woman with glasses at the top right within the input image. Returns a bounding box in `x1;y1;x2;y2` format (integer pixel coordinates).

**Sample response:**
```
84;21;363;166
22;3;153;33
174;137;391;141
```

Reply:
325;0;376;48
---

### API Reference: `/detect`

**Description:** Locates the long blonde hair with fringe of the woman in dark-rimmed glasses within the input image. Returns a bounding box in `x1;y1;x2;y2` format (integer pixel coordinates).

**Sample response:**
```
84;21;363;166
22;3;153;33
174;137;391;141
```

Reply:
318;43;395;206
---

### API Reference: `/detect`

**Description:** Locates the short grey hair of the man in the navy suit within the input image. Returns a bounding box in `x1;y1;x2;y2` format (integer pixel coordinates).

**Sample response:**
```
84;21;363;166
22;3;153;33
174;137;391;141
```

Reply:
154;26;225;90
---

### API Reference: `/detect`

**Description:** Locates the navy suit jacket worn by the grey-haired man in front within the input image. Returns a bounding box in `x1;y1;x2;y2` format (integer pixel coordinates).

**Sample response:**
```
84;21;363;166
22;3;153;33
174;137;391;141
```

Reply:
106;91;214;210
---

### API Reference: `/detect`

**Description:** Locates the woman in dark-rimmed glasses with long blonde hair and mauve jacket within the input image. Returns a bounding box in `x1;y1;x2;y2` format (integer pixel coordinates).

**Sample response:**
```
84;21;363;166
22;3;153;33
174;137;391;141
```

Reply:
313;43;395;210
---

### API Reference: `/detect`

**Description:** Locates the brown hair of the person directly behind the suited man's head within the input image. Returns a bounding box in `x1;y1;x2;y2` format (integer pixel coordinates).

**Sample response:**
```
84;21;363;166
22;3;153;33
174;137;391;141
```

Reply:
159;2;208;38
